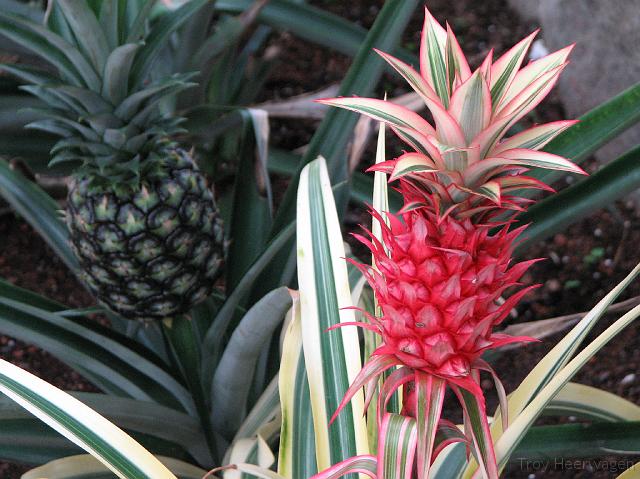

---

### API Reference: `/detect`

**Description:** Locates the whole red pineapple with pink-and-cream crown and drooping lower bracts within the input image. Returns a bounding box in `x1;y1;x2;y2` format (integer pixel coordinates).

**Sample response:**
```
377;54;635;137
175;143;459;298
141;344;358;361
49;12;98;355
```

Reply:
319;9;584;479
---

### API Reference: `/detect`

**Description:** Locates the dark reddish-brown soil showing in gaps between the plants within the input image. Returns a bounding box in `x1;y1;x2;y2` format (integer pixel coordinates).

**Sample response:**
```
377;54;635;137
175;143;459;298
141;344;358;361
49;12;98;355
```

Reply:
0;0;640;479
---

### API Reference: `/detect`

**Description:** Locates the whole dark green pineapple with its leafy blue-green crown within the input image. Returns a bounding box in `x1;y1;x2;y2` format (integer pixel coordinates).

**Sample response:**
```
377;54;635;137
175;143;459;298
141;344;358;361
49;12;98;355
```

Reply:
0;0;225;320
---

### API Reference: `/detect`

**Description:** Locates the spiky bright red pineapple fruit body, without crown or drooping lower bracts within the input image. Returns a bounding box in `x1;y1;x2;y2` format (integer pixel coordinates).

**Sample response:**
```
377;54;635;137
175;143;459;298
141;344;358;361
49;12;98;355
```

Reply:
359;208;535;378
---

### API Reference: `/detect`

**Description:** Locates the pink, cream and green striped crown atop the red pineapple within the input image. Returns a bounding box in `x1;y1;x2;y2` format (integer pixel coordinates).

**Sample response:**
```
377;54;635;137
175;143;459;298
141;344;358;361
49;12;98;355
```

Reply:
319;9;585;221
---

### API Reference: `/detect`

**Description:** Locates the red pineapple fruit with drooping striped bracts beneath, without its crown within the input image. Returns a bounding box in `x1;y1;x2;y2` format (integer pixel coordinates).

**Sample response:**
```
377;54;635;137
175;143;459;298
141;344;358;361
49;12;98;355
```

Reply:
334;208;537;479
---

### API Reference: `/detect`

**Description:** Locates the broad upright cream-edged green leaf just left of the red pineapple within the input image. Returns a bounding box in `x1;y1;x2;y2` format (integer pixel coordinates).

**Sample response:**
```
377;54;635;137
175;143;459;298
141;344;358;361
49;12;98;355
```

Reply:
297;158;368;469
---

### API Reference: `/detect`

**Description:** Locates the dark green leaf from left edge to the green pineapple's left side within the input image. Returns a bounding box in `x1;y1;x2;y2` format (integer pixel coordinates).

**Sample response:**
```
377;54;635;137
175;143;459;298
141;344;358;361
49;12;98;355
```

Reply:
0;158;79;272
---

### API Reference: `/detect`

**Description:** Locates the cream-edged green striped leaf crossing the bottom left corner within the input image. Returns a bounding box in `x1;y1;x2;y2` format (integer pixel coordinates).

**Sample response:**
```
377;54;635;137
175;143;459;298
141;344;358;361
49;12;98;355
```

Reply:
0;360;175;479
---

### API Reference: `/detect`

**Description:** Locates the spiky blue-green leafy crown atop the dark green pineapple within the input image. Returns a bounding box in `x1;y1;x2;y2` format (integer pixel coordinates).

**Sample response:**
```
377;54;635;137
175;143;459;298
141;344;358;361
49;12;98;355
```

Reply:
0;0;206;189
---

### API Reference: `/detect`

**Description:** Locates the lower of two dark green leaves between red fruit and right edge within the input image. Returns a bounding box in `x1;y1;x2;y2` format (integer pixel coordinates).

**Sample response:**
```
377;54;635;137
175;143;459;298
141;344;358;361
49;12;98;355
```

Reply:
518;146;640;251
